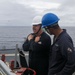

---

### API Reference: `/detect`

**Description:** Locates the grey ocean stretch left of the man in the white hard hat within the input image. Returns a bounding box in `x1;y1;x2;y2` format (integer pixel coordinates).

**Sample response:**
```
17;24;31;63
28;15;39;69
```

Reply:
0;26;32;49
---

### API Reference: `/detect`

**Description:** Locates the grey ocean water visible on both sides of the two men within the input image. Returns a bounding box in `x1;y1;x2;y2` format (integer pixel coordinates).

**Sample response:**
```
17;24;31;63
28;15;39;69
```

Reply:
0;26;75;61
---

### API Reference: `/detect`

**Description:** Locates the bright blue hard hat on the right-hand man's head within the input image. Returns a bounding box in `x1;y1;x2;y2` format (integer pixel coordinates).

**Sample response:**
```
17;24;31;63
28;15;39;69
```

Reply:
42;13;59;27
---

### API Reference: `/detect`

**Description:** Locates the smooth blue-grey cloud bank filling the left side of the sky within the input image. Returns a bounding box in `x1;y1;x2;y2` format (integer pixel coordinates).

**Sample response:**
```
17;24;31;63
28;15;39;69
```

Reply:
0;1;35;26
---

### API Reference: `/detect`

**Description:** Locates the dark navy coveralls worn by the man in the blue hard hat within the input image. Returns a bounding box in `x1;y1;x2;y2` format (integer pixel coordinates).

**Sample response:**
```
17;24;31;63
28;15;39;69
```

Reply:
48;30;75;75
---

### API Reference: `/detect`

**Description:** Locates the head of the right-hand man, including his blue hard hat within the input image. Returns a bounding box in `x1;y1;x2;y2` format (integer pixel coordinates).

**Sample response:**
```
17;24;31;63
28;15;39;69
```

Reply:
42;13;60;34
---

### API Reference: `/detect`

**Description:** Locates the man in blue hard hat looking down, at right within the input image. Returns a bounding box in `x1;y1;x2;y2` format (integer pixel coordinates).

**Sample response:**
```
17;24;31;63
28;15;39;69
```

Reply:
42;13;75;75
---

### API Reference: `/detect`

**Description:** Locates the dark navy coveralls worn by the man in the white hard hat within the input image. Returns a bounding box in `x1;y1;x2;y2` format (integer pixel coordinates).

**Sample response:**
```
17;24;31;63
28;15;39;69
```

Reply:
23;32;51;75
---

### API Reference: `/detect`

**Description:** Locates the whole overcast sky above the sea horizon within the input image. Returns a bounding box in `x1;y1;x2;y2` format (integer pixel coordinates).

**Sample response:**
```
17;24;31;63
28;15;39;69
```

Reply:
0;0;75;26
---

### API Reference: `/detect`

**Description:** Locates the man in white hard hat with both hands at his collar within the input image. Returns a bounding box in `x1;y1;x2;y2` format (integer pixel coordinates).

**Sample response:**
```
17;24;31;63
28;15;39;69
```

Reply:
23;16;51;75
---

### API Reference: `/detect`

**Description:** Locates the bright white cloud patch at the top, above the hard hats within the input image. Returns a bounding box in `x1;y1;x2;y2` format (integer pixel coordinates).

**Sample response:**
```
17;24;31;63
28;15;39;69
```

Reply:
17;0;60;13
